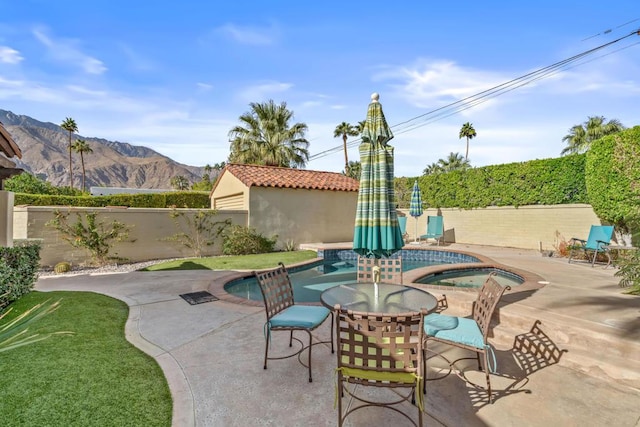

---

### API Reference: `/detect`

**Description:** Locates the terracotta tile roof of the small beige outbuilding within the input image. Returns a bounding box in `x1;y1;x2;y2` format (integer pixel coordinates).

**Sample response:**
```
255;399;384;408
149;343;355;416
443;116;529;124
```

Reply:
218;164;359;191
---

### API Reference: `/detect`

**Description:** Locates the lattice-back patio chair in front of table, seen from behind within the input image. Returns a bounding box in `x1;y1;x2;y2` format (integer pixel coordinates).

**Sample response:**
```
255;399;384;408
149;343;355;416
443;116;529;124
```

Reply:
335;305;426;426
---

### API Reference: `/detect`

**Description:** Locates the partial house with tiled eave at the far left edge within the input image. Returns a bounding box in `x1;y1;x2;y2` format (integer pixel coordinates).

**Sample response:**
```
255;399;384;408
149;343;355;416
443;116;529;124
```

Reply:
0;123;22;246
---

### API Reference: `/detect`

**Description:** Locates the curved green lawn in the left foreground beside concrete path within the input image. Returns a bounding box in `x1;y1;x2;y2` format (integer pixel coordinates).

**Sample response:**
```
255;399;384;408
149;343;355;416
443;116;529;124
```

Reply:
0;292;172;426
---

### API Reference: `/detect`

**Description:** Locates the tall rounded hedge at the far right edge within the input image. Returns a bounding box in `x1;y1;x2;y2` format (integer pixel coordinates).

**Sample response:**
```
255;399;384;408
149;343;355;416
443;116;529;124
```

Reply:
585;126;640;231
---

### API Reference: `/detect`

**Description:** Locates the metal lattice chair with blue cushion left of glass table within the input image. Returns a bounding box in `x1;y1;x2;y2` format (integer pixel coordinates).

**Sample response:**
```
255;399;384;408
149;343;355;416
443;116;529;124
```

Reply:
254;263;334;382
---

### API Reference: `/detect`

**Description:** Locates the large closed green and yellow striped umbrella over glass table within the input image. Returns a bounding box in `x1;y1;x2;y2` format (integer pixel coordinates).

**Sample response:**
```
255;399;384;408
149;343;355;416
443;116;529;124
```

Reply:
353;93;404;258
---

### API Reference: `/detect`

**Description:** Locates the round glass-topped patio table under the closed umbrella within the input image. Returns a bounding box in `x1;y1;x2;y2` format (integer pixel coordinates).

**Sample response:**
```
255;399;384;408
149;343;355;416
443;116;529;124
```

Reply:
320;283;437;313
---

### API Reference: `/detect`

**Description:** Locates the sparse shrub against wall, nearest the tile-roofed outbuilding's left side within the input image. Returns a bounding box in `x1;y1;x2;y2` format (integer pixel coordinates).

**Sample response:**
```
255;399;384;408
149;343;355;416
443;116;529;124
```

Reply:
163;209;231;258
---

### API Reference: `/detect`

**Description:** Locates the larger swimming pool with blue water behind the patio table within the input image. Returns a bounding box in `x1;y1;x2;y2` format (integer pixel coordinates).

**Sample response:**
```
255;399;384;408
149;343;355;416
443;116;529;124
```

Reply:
224;248;480;302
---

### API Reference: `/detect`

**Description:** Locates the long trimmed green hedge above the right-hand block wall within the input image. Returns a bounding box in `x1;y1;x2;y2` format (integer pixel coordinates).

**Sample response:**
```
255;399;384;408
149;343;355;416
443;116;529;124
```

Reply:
396;154;588;209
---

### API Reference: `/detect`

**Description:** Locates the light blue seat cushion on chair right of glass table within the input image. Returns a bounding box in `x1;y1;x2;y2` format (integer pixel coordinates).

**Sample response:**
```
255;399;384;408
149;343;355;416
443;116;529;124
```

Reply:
424;313;485;349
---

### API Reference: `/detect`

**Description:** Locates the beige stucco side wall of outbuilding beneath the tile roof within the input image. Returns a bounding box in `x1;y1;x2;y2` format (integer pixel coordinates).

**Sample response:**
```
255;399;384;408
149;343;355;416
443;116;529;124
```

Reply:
249;187;358;248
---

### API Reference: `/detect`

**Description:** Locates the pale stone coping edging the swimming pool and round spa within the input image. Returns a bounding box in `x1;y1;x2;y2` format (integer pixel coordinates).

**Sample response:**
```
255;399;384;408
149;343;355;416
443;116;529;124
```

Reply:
208;246;546;307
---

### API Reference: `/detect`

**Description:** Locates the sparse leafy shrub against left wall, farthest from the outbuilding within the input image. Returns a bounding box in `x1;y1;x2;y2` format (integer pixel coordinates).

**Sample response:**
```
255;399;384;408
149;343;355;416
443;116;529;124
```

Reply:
46;209;129;265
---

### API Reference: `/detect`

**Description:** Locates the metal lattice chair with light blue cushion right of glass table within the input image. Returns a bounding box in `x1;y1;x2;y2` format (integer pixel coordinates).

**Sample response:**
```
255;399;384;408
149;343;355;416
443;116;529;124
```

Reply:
423;273;510;403
